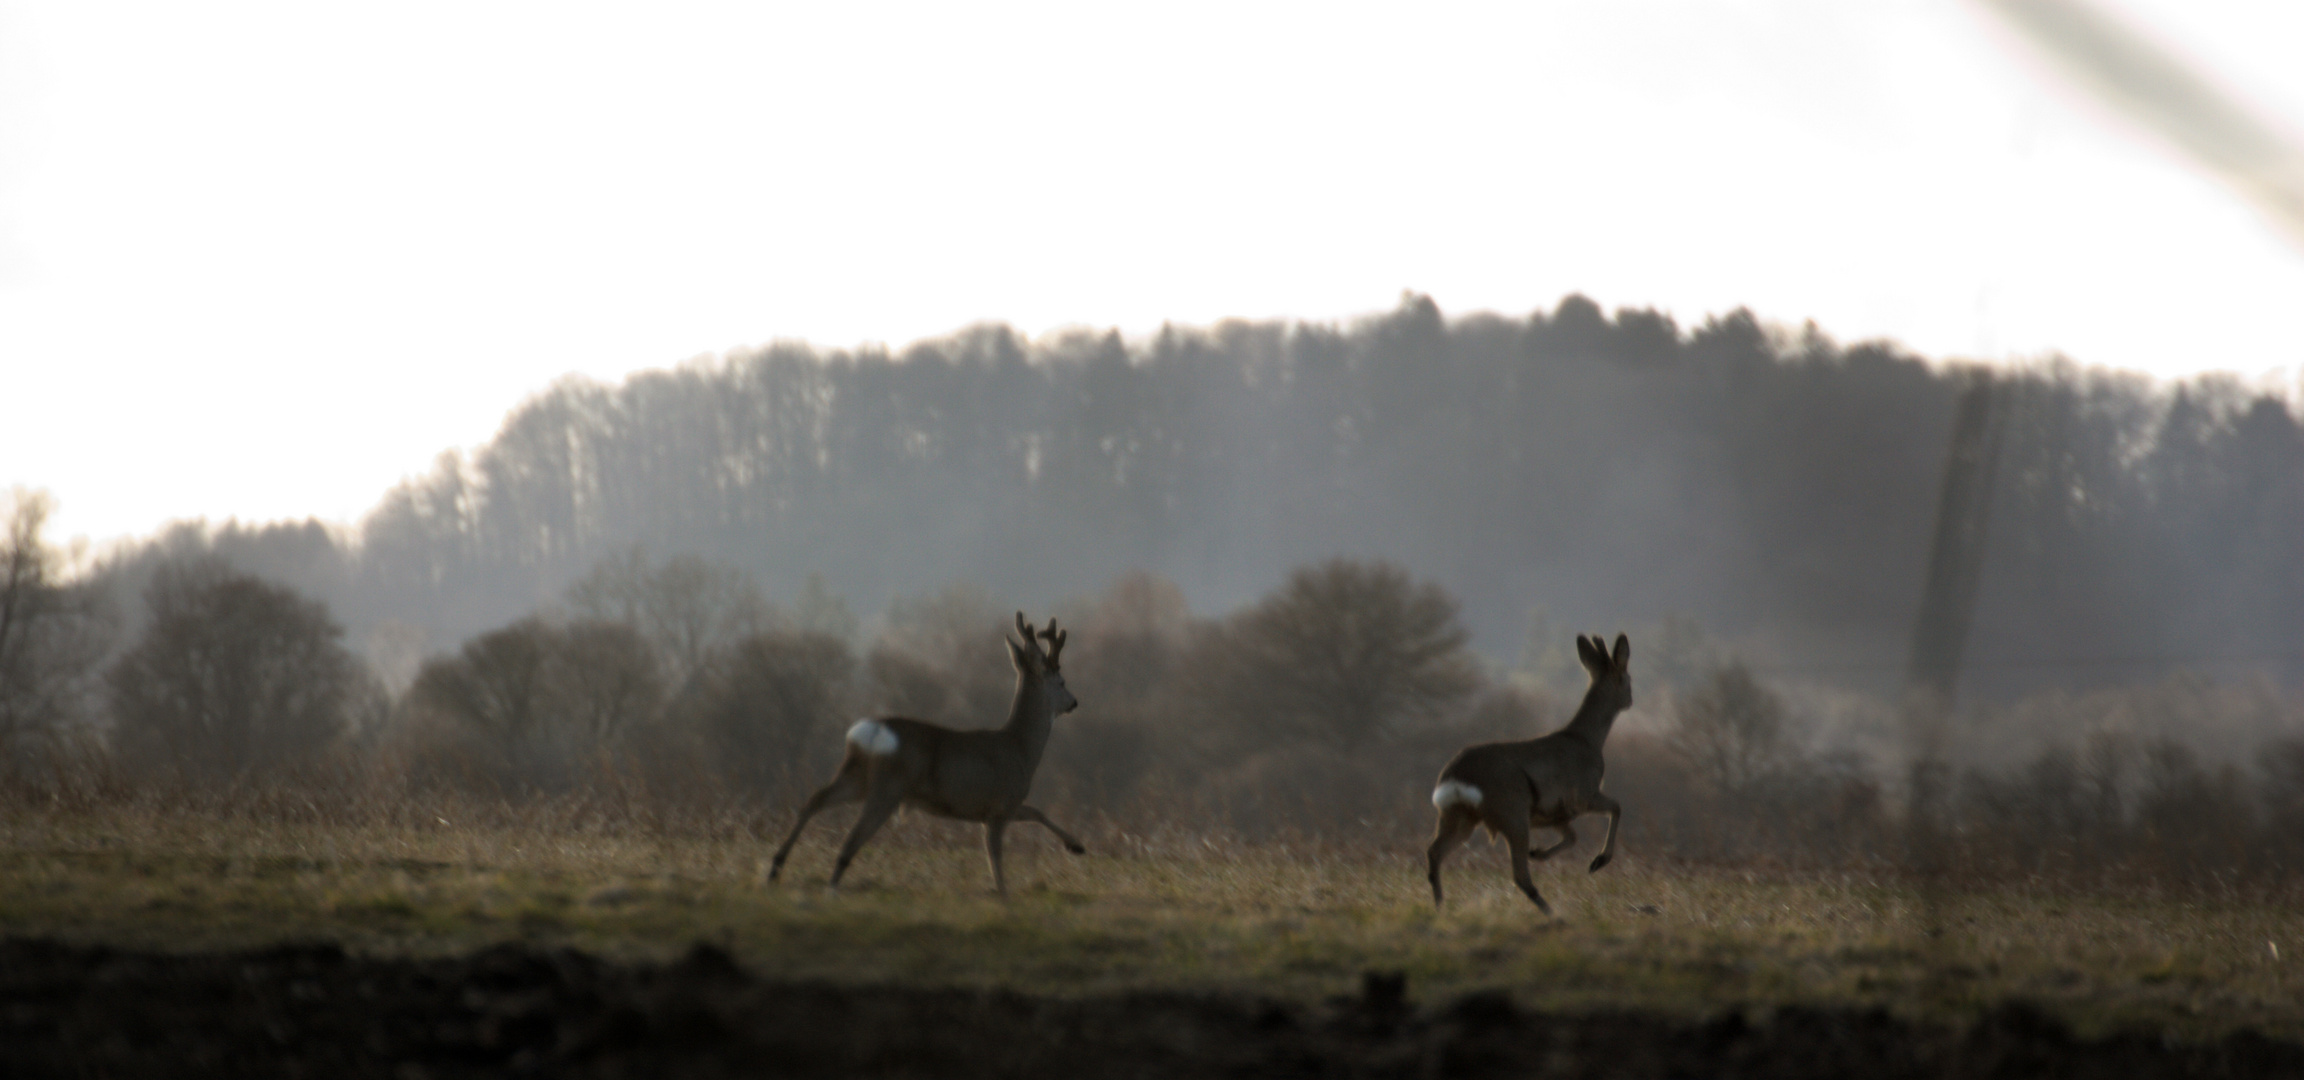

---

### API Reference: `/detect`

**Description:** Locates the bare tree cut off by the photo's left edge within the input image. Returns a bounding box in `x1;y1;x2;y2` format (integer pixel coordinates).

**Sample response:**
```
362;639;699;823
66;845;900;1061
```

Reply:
0;488;115;760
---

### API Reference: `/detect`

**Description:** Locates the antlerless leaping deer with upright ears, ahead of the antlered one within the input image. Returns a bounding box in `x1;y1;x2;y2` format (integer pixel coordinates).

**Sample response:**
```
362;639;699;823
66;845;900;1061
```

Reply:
1424;633;1631;914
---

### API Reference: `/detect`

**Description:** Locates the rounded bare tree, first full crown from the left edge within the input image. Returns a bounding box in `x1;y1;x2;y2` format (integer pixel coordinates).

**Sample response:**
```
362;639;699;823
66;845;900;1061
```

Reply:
106;560;373;781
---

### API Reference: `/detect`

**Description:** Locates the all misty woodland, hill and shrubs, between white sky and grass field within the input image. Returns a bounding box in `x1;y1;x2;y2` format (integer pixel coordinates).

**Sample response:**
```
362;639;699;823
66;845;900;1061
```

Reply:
0;295;2304;880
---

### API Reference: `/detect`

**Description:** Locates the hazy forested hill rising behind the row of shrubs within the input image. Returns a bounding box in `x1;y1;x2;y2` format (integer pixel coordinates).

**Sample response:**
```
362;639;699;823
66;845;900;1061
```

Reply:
126;297;2304;693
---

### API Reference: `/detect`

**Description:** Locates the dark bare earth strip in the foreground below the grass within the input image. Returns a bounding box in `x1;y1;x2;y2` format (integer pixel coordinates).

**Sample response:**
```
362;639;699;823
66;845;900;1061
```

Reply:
0;940;2304;1080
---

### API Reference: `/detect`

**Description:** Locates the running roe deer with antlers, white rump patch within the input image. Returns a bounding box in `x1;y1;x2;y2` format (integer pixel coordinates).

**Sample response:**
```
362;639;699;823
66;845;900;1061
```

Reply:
767;613;1087;900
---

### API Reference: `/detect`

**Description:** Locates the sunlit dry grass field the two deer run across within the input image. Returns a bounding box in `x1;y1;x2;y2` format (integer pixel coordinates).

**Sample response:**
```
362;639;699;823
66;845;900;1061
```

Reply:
0;808;2304;1039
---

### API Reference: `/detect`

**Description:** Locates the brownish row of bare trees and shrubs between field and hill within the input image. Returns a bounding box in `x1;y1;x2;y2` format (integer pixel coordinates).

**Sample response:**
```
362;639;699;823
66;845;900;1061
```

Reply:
0;502;2304;889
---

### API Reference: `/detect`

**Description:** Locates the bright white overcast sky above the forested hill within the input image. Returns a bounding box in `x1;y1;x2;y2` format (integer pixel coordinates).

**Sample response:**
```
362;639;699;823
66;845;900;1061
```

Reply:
0;0;2304;541
